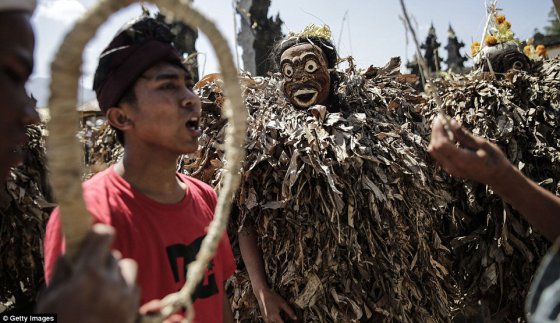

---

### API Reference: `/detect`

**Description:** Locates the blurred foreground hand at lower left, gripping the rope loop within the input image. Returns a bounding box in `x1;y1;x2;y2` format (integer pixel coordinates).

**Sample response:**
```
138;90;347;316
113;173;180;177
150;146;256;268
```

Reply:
36;224;140;323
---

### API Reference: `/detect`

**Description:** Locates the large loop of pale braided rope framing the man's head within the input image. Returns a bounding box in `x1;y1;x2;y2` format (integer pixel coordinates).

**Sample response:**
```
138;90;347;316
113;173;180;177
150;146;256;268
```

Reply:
48;0;243;322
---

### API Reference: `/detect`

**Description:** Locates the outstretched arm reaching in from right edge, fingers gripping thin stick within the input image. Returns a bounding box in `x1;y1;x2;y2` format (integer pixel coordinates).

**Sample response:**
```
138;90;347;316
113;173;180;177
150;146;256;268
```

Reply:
428;117;560;241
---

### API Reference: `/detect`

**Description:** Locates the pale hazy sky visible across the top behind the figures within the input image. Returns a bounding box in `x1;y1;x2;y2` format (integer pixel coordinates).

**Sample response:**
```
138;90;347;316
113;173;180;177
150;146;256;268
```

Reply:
32;0;552;88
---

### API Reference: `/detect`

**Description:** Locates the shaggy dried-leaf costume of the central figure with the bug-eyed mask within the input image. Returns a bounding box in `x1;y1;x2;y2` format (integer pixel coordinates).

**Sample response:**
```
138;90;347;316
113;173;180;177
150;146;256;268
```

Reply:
183;26;455;322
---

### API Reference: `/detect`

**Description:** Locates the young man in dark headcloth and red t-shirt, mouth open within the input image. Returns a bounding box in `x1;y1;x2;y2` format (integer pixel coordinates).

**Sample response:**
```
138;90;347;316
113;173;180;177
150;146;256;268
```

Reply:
45;17;235;322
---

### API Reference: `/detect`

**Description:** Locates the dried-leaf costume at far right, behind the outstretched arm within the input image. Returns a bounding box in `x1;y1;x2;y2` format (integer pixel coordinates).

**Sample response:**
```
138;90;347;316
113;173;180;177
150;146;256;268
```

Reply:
421;58;560;322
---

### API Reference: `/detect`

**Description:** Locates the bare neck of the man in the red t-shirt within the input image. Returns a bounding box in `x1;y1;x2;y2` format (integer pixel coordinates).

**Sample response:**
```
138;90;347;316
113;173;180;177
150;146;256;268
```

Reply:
115;149;187;204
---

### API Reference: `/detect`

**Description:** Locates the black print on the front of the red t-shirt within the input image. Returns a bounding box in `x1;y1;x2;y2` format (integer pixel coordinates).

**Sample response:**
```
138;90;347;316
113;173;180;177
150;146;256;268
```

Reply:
166;235;218;302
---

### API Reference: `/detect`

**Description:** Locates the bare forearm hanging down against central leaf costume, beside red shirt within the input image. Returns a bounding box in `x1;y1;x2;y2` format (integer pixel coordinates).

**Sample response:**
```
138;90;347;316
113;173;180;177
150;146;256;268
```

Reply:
239;229;297;323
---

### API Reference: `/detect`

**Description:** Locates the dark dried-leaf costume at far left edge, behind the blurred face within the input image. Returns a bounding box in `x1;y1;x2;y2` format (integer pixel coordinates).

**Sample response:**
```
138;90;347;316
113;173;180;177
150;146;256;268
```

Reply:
0;125;54;313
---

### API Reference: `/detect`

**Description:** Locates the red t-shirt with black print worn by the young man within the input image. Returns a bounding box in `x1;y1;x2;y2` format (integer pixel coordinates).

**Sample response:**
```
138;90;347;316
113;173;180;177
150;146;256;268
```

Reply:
44;167;235;322
